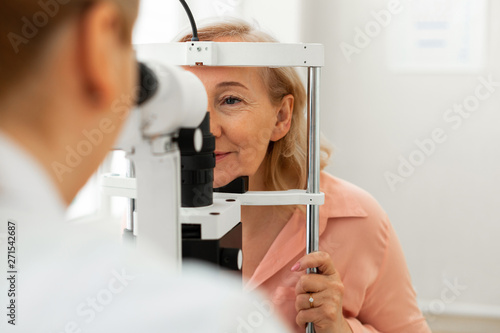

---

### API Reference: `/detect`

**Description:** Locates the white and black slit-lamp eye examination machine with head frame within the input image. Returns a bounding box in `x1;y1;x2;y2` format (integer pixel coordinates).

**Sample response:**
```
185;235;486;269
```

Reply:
102;1;324;332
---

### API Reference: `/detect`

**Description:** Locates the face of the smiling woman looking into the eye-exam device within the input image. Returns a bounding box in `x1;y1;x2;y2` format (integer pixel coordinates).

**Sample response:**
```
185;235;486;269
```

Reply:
187;67;293;187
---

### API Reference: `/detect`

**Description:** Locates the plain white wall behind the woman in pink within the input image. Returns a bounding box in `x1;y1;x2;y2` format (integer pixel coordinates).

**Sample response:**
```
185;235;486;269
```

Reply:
302;0;500;332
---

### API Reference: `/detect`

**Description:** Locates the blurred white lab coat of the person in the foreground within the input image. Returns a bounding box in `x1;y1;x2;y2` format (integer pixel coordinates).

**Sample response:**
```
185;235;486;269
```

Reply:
0;133;287;333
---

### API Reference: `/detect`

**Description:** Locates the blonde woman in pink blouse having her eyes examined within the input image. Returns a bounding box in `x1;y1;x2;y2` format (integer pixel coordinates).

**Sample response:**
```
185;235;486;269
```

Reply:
180;21;430;333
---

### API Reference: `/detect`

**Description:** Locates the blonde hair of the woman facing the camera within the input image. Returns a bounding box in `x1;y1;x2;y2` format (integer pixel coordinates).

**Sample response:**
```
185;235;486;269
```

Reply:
177;19;331;191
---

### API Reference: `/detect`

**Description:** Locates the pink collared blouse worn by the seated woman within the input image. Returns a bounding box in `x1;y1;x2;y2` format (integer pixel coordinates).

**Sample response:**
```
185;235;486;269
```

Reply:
245;172;430;333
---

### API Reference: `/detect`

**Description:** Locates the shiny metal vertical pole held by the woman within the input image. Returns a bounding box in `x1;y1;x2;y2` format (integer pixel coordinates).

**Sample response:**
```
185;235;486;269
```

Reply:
306;67;321;333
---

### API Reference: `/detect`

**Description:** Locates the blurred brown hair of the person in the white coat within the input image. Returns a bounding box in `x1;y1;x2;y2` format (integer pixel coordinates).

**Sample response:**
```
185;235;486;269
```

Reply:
0;0;139;97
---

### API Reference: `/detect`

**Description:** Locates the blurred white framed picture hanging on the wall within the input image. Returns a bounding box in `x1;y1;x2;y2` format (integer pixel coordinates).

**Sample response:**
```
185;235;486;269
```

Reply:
387;0;488;73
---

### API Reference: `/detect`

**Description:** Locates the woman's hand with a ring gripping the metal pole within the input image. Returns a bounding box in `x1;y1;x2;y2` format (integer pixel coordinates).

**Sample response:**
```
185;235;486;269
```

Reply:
292;252;352;333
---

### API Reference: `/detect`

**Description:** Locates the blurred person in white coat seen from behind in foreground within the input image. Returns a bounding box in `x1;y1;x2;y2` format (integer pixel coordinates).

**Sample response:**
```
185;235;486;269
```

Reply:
0;0;285;333
